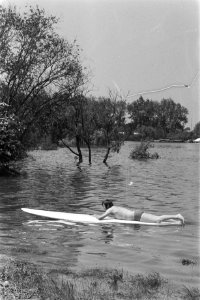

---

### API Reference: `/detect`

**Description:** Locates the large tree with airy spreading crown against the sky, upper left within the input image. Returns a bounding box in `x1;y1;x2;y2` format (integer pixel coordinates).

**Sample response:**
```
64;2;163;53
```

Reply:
0;6;84;141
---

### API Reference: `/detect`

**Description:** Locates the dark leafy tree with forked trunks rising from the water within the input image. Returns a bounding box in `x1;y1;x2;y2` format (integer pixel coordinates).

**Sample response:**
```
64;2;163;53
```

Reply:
39;94;96;164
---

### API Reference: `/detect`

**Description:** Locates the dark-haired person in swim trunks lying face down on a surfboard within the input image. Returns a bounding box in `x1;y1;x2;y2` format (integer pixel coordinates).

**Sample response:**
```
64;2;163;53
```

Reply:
97;199;184;225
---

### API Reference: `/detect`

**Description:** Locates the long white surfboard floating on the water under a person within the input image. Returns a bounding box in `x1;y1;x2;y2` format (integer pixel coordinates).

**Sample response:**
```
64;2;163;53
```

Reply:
22;208;181;226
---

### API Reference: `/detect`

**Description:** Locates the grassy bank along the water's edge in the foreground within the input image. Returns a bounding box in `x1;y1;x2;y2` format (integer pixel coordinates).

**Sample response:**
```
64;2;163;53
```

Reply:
0;261;200;300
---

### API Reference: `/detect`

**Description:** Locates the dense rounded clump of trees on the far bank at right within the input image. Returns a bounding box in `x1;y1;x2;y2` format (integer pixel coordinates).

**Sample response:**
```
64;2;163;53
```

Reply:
127;97;188;139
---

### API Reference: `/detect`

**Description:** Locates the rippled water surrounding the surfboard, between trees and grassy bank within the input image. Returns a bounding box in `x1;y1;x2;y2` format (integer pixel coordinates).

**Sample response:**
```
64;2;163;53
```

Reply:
0;142;200;287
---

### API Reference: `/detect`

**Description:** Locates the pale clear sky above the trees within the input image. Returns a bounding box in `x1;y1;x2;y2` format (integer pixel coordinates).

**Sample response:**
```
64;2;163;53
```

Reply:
0;0;200;127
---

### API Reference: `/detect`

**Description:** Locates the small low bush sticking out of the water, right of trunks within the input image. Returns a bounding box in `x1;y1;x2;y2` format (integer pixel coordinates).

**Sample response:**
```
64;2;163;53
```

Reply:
130;141;159;159
